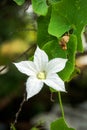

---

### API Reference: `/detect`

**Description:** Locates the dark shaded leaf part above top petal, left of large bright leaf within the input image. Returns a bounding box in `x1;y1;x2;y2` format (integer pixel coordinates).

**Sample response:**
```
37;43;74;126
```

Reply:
37;8;54;47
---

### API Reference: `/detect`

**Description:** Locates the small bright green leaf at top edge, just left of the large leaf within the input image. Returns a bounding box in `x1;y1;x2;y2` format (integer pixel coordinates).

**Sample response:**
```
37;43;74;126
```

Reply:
32;0;48;16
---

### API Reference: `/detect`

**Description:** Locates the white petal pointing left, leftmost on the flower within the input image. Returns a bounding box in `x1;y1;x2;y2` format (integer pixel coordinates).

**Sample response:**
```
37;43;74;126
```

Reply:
13;61;36;76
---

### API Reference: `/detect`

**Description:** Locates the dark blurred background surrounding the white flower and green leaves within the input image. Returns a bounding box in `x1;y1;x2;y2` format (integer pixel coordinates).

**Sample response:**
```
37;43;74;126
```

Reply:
0;0;87;130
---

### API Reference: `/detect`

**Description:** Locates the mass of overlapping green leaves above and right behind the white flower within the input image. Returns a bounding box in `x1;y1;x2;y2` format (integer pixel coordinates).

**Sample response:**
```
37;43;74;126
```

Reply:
37;0;87;81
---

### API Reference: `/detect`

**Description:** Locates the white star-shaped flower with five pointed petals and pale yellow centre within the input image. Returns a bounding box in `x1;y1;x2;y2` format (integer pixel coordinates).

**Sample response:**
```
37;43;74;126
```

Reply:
14;47;67;99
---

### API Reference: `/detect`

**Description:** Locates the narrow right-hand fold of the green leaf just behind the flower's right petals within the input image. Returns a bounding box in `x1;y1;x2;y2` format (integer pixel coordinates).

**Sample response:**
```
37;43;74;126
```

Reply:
58;35;77;81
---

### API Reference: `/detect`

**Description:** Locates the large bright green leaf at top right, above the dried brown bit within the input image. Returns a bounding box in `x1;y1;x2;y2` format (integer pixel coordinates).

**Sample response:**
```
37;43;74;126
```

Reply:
49;0;87;51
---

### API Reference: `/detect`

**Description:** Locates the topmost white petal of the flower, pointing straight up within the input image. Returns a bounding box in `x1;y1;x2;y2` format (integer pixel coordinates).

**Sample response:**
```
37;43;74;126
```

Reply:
34;47;48;71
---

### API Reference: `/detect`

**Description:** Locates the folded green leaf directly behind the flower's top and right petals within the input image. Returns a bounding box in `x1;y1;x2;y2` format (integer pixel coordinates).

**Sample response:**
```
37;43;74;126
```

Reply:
43;35;77;81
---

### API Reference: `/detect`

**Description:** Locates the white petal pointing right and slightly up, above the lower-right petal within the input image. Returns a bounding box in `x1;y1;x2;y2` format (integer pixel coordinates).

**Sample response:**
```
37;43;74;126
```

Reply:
46;58;67;73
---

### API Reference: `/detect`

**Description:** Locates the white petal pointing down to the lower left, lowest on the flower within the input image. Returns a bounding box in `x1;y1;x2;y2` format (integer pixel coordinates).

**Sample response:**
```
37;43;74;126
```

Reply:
26;77;43;99
